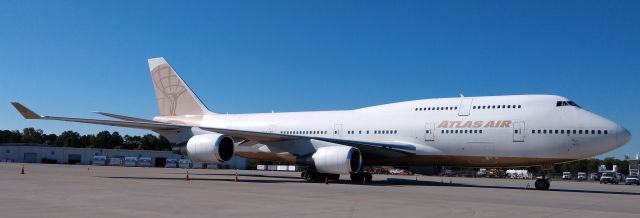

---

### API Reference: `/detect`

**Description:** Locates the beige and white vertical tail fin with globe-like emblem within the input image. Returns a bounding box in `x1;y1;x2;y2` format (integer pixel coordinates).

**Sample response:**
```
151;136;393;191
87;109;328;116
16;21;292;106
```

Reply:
148;57;211;116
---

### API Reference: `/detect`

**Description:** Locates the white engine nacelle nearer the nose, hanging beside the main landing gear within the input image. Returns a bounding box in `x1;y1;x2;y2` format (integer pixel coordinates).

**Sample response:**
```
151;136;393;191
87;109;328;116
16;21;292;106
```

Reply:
311;145;362;174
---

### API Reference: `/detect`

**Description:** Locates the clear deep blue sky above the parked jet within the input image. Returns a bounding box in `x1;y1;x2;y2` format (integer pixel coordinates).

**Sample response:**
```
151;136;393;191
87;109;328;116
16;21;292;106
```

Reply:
0;0;640;158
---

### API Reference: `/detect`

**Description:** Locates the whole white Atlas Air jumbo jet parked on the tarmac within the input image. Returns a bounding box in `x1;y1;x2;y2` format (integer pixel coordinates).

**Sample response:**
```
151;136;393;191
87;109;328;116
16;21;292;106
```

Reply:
12;57;631;190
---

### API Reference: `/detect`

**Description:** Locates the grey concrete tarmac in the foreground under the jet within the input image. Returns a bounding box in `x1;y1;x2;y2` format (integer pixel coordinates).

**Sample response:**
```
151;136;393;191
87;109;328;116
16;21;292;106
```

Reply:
0;163;640;218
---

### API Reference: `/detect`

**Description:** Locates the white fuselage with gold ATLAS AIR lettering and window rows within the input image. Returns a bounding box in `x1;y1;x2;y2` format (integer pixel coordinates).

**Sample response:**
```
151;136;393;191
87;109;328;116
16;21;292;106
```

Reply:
155;95;630;166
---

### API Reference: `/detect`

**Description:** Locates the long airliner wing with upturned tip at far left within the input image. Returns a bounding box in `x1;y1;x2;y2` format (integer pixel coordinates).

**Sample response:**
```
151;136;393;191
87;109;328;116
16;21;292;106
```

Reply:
11;102;416;157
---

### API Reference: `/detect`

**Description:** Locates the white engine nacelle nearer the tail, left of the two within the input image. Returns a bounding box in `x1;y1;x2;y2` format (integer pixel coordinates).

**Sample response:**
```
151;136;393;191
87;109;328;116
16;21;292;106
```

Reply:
180;133;234;163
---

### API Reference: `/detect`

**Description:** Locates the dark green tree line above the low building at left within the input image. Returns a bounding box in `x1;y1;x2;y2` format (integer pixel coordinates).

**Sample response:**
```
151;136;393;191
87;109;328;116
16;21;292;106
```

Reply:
0;128;172;151
